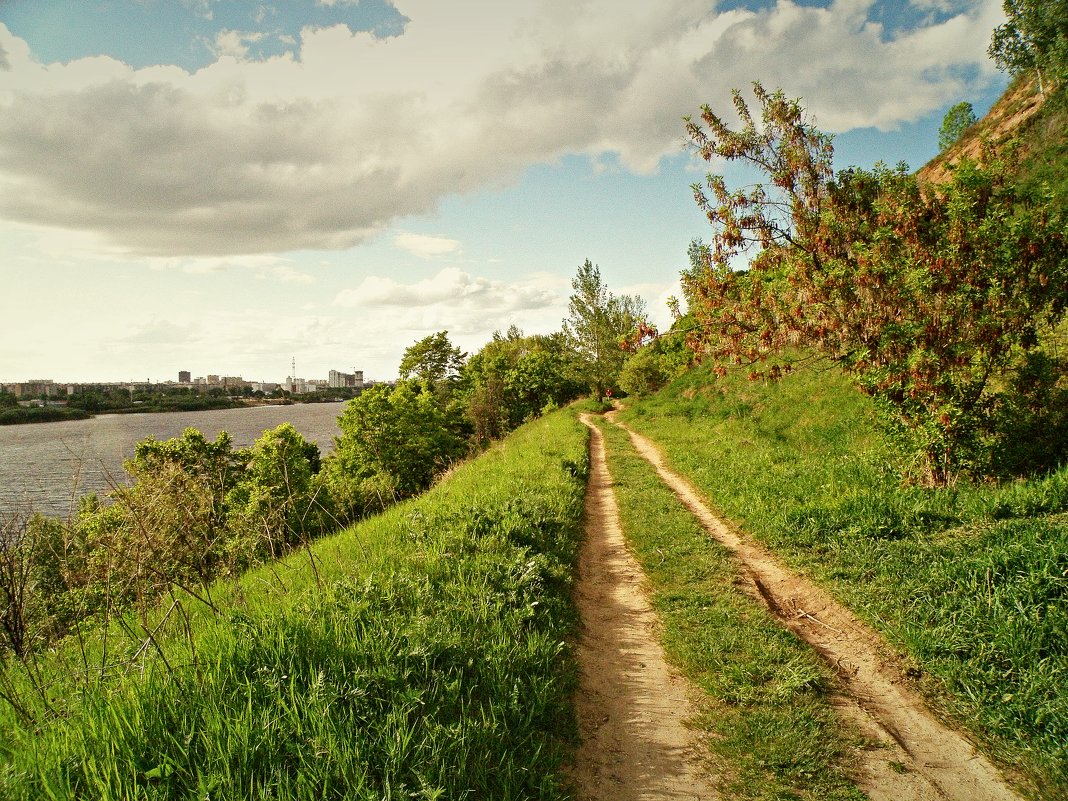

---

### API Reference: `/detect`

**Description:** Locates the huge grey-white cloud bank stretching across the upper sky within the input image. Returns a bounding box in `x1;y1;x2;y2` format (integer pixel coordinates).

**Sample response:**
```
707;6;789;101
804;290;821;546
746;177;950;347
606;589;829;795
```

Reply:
0;0;1001;256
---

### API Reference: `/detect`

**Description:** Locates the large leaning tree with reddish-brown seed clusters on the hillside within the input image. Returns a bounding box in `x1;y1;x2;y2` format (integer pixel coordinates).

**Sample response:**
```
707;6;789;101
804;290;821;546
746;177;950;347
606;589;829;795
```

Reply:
682;83;1068;484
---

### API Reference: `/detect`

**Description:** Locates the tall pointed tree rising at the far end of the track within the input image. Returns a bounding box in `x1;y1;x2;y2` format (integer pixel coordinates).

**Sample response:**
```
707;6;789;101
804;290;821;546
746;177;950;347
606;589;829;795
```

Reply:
563;258;646;401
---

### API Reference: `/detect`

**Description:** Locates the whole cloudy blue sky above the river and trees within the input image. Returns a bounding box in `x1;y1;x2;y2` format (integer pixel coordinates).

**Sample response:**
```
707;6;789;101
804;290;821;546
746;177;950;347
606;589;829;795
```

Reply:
0;0;1006;382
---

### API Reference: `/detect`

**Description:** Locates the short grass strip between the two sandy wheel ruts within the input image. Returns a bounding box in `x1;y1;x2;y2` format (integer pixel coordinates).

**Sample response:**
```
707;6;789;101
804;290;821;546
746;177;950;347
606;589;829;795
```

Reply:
601;414;864;801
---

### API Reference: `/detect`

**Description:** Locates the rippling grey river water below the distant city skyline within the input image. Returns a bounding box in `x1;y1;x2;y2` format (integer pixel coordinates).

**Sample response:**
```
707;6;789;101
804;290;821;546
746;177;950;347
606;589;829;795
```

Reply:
0;403;345;518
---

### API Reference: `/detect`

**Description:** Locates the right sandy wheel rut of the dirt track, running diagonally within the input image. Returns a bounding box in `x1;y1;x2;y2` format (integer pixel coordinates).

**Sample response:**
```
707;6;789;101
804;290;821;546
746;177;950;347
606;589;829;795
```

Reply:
595;414;1019;801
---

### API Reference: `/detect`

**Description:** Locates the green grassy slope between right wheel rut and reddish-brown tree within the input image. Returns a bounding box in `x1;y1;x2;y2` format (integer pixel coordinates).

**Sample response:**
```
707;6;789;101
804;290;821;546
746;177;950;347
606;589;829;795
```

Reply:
624;371;1068;799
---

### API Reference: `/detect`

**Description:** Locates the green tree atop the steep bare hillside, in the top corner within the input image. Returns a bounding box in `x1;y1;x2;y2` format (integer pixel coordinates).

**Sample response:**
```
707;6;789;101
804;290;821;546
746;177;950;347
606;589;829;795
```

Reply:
988;0;1068;96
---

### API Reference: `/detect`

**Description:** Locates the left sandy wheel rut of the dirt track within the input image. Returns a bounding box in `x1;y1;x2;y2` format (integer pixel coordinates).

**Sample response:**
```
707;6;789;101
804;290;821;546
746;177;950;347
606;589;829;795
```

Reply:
575;415;718;801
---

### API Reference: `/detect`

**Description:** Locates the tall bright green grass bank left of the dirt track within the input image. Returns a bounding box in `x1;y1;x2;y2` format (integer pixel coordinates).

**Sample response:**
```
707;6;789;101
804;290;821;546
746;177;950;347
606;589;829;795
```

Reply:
0;412;586;801
